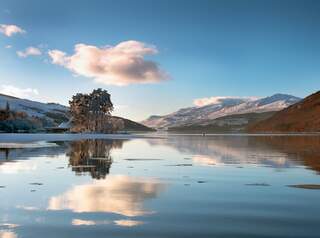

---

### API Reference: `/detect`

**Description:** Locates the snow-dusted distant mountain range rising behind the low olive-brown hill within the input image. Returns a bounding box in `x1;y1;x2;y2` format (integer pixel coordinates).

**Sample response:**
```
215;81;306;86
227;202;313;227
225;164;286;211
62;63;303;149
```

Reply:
142;94;301;129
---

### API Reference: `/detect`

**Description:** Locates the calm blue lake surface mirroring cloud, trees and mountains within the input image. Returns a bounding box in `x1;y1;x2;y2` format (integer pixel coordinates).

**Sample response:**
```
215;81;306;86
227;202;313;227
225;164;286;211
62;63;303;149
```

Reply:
0;136;320;238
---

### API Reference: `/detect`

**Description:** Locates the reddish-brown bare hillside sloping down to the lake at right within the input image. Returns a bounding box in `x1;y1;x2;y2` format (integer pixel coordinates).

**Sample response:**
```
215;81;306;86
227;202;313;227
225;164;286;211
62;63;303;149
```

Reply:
249;91;320;132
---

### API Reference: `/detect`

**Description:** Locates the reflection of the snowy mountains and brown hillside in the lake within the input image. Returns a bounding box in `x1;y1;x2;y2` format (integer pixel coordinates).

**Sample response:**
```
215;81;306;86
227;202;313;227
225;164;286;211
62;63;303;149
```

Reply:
148;136;320;172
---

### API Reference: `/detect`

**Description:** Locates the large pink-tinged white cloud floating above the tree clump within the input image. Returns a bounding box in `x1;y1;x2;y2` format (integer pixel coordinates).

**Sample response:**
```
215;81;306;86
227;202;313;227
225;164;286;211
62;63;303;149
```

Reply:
48;41;169;86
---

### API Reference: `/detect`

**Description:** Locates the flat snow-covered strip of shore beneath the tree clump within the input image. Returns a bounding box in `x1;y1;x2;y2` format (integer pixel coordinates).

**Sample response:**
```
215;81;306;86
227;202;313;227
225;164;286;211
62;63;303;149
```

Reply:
0;133;154;143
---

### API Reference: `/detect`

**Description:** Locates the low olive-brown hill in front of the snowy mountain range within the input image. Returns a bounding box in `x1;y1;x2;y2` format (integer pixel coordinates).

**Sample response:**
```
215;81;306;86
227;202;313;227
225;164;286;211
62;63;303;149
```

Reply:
168;112;276;133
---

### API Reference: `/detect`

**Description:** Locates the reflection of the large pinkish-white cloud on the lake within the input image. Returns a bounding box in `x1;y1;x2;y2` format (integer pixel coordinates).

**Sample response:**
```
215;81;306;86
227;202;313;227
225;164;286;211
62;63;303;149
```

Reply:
48;175;164;217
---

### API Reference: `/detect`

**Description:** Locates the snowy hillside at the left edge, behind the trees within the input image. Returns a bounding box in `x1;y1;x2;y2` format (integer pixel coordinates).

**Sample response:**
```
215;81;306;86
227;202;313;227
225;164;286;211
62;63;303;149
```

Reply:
0;94;69;125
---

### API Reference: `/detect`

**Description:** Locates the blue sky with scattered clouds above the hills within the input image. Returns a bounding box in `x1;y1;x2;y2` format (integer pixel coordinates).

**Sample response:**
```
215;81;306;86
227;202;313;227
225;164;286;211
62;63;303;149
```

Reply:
0;0;320;121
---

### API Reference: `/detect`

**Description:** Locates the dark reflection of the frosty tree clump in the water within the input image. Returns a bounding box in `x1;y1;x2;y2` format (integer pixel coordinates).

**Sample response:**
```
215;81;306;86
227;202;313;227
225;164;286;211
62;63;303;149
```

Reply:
67;140;123;179
